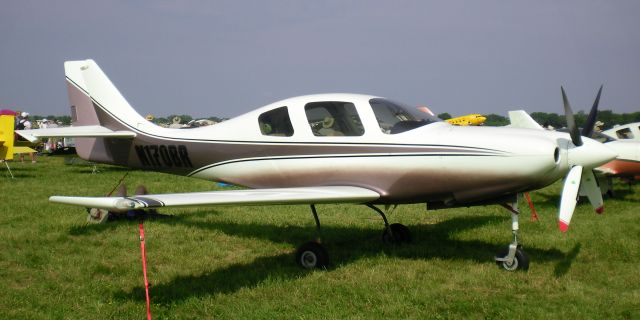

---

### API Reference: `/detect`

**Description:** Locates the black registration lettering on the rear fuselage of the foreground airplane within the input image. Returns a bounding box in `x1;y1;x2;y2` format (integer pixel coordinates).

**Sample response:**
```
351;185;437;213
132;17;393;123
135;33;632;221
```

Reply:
135;145;193;168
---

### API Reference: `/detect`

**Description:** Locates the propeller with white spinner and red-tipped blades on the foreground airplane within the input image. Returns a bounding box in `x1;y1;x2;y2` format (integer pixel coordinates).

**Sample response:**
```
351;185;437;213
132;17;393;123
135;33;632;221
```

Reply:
558;86;615;232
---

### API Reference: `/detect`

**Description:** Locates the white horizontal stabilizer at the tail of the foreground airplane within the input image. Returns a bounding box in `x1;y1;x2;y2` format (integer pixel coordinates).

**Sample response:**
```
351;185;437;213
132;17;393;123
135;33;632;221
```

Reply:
16;126;136;142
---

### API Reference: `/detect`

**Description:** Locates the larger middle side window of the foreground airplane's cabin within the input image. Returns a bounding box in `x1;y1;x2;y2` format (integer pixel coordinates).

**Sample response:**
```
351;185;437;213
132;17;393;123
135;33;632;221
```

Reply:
304;101;364;137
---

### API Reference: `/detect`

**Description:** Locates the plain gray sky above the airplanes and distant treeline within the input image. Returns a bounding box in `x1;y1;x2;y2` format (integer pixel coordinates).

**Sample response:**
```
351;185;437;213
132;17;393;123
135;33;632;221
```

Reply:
0;0;640;117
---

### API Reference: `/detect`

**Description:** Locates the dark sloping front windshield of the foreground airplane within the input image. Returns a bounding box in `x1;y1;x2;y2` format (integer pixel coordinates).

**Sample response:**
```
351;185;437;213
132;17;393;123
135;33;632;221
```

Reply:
369;98;441;134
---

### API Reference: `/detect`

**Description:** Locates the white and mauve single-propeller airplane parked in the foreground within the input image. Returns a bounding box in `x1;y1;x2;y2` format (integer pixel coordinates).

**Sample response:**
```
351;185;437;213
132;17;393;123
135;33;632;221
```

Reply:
19;60;616;271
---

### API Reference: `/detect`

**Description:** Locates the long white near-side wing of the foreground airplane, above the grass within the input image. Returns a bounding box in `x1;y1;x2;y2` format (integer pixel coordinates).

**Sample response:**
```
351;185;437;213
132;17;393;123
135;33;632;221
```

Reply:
49;186;380;211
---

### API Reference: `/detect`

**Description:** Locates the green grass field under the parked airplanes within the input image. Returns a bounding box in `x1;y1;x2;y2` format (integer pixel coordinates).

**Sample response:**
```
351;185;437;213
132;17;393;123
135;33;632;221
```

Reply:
0;157;640;319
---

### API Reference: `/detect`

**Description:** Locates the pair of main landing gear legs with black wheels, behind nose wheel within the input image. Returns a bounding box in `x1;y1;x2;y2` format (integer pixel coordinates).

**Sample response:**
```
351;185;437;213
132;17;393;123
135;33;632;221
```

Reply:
295;204;411;269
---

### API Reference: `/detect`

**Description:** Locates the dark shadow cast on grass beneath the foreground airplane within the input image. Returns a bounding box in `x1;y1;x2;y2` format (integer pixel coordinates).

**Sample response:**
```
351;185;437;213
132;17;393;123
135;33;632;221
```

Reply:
111;216;568;304
